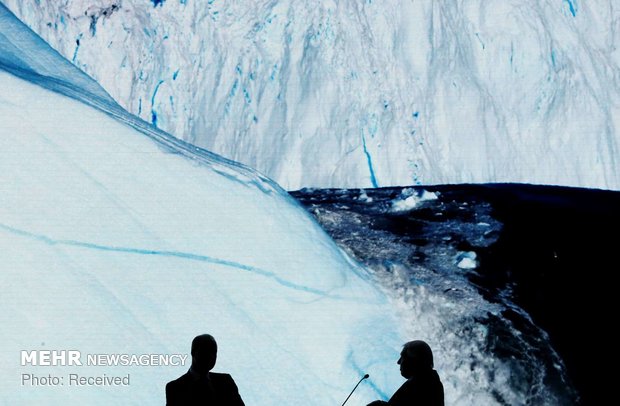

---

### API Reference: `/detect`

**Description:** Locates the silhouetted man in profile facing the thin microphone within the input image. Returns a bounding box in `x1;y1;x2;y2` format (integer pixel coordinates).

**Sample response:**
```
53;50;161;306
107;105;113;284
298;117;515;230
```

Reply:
367;340;444;406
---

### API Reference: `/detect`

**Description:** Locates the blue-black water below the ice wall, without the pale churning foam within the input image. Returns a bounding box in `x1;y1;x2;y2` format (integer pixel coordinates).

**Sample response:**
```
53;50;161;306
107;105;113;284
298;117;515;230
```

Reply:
292;184;620;405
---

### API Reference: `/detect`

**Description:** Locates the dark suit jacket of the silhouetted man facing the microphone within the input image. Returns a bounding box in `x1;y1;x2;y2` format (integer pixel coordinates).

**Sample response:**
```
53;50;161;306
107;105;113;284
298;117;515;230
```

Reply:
387;369;444;406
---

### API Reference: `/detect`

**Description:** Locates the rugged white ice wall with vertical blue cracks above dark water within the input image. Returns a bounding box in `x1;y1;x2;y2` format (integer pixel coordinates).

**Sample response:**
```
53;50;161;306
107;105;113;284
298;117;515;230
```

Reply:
3;0;620;189
